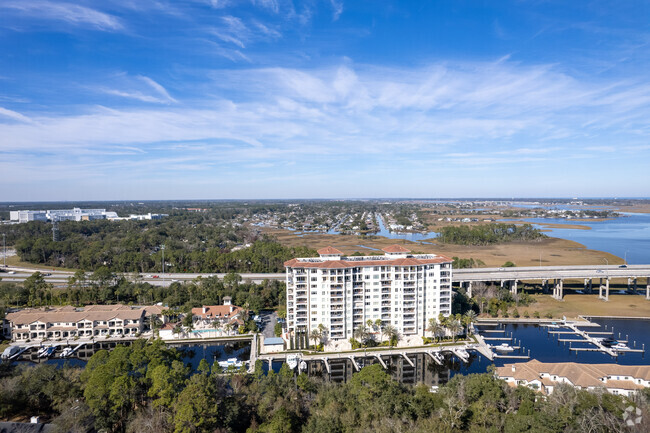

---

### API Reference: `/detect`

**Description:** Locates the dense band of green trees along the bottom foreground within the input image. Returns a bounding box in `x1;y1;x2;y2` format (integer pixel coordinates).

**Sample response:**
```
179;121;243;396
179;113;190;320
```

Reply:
0;340;650;433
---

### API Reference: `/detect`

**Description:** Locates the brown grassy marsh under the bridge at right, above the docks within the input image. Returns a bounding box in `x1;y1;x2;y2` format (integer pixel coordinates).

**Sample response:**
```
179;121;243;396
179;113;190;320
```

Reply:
519;290;650;318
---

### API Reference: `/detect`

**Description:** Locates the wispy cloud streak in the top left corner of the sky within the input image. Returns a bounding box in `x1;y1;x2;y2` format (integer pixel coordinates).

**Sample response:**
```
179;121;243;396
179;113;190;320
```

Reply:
0;0;124;31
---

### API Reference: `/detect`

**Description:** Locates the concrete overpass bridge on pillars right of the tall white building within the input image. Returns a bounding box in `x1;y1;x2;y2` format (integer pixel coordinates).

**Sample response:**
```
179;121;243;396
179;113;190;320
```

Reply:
452;265;650;301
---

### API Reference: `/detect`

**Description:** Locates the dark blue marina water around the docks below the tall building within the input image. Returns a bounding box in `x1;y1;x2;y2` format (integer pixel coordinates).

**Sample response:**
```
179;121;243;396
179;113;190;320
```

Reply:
12;318;650;385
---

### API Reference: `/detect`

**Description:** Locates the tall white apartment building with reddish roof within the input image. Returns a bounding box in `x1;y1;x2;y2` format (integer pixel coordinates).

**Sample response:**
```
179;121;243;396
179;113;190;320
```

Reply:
284;245;452;340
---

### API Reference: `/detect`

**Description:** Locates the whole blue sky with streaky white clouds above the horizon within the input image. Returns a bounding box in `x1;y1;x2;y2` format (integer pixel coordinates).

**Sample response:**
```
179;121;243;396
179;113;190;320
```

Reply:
0;0;650;201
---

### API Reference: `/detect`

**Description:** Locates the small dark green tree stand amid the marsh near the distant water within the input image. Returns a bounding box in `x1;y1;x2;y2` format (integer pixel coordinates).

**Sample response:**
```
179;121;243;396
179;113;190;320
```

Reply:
437;224;546;245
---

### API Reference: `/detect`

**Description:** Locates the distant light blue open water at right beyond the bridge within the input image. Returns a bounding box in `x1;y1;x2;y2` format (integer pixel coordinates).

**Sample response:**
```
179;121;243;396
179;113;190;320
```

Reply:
524;213;650;264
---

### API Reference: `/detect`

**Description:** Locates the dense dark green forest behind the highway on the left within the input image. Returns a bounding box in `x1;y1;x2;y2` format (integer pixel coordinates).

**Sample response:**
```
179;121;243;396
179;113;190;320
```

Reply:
4;214;316;272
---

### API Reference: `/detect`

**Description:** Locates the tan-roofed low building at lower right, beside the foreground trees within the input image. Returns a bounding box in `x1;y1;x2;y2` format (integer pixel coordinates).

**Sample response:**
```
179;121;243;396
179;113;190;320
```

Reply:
496;359;650;397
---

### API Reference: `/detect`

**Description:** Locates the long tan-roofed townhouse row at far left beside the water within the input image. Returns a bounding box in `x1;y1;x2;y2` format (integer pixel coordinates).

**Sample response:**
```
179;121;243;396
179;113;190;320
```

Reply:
5;305;161;341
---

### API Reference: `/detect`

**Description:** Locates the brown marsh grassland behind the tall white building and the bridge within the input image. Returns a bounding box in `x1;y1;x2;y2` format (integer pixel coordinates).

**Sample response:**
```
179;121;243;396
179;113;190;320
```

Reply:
265;229;623;267
